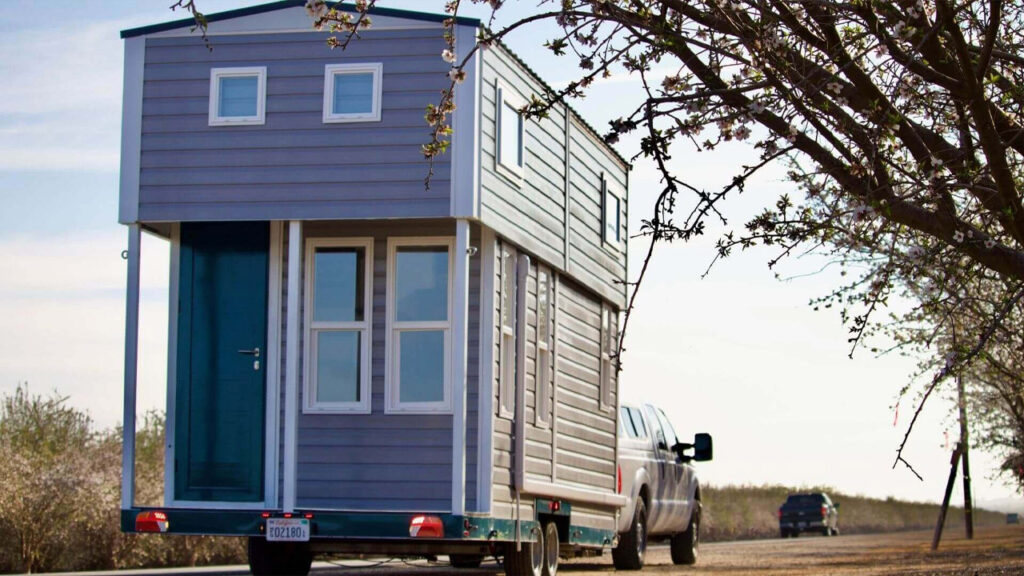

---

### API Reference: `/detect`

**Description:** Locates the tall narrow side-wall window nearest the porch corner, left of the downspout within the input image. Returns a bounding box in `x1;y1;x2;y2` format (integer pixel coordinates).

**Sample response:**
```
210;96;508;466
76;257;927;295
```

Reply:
498;240;518;420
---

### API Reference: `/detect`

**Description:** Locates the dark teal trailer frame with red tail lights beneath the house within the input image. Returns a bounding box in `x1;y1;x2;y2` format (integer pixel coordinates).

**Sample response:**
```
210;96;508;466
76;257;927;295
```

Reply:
121;506;615;553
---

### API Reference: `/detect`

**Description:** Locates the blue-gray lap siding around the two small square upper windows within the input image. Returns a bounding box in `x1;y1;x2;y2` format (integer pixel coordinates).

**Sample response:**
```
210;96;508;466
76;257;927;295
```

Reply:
139;26;451;221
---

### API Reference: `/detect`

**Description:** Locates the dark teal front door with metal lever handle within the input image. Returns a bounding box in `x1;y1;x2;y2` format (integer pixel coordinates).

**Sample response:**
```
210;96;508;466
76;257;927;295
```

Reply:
174;222;269;502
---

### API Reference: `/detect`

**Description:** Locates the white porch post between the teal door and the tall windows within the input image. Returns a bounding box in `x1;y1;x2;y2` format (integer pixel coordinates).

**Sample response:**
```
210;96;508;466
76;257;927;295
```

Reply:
282;220;302;512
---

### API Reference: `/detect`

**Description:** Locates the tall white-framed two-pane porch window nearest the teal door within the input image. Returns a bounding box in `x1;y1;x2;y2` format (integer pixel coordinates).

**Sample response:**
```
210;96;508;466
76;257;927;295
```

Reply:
303;239;373;414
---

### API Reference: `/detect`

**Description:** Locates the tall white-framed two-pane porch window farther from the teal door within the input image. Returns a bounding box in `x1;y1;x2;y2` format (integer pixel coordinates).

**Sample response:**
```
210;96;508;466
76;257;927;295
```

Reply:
385;238;453;413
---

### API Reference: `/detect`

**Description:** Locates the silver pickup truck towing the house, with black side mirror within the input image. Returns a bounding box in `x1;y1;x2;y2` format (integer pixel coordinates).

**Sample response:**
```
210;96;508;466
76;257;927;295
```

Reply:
611;404;712;570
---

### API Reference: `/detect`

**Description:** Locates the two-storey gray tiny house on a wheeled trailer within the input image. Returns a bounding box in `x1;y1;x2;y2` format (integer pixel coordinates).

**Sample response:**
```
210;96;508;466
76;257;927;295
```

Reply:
120;0;629;574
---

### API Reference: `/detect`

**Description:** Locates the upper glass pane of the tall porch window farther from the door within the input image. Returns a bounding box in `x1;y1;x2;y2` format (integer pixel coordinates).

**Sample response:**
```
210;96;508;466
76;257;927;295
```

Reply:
395;246;449;322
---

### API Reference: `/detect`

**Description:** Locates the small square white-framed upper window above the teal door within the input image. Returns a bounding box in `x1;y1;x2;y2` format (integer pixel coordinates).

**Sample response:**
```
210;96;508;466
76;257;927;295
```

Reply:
209;67;266;126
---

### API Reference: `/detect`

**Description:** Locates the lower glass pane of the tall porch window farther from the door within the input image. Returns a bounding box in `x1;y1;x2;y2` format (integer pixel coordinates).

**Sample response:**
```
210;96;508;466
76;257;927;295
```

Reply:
398;330;444;403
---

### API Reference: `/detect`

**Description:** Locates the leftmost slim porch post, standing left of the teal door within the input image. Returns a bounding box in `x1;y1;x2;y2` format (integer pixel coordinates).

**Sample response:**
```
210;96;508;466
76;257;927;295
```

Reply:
121;223;142;509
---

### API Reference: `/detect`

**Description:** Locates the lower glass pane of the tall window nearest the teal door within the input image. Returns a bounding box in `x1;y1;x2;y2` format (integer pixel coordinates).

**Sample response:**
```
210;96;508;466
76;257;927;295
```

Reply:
316;331;361;402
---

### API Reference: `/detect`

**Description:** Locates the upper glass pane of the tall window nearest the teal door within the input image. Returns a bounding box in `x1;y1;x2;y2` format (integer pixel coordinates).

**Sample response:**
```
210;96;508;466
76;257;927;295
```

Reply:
313;248;366;322
